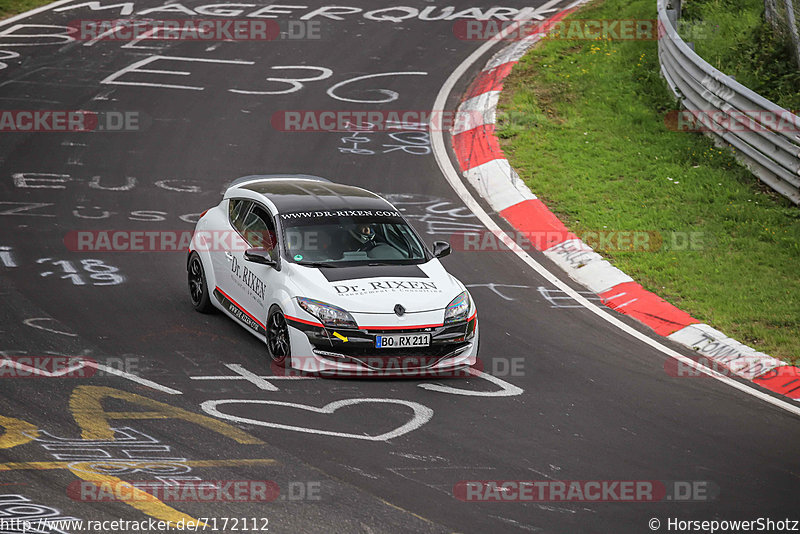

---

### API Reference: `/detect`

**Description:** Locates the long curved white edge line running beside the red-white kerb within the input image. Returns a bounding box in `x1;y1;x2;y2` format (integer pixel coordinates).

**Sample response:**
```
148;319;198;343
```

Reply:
430;7;800;416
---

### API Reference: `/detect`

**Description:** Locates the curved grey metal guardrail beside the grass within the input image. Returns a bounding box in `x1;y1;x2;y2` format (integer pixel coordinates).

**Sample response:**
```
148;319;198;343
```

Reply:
657;0;800;205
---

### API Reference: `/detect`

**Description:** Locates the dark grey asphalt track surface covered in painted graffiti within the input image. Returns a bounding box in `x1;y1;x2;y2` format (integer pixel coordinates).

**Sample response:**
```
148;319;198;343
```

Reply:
0;1;800;532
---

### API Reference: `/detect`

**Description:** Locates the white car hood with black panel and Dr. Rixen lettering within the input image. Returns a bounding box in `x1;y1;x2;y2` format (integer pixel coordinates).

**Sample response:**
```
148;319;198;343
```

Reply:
288;259;464;313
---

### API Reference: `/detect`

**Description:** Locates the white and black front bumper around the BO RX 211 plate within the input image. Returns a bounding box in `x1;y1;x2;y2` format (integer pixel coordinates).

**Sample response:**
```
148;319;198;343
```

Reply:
287;316;478;377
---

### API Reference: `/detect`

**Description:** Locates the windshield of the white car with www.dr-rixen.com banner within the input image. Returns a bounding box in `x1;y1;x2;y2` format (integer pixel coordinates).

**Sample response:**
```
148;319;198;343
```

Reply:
281;211;428;267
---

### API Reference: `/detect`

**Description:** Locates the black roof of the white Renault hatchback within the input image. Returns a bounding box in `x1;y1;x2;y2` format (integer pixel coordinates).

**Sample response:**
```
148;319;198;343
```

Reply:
231;175;394;213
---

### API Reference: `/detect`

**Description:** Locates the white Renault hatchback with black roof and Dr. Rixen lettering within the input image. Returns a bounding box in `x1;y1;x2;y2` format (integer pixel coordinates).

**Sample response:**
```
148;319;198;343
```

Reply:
187;175;478;376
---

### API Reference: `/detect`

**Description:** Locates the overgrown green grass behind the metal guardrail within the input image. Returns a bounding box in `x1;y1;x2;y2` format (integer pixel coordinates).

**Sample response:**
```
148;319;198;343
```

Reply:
679;0;800;110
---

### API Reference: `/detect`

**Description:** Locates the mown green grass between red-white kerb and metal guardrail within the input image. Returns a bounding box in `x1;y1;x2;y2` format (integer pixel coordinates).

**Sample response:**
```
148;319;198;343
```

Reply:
498;0;800;363
